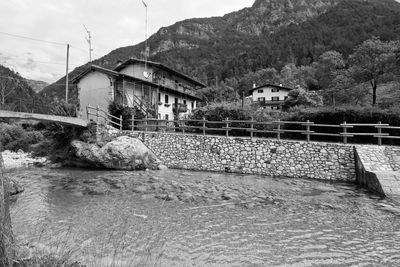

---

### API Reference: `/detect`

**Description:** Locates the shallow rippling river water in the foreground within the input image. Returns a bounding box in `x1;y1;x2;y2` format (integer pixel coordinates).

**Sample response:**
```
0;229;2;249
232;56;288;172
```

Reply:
10;169;400;266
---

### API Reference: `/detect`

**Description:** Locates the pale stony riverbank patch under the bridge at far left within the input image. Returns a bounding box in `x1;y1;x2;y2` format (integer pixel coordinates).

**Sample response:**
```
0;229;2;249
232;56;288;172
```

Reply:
2;150;51;170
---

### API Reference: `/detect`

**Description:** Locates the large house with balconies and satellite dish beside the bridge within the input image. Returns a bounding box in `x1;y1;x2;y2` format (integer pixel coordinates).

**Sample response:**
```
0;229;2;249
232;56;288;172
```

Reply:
72;58;205;120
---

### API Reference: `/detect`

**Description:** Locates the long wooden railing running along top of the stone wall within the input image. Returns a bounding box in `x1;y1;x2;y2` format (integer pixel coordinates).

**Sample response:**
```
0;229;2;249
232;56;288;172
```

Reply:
126;117;400;145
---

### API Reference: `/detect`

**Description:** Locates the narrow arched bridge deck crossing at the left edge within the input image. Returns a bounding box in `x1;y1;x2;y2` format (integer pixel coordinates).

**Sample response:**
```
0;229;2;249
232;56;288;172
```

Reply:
0;110;88;127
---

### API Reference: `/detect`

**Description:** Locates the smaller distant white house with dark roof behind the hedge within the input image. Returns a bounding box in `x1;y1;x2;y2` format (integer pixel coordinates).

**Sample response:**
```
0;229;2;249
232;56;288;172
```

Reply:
250;84;293;110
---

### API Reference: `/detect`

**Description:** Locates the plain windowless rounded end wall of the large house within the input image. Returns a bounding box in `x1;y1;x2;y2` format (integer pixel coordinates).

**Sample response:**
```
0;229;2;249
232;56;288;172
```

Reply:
78;71;114;119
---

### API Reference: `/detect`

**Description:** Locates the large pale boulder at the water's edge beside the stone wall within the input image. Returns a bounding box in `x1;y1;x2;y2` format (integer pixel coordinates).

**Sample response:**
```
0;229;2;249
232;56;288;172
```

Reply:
71;136;161;170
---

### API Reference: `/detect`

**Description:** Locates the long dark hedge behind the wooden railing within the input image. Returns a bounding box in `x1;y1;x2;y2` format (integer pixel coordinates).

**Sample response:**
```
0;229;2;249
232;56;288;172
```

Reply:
186;103;400;145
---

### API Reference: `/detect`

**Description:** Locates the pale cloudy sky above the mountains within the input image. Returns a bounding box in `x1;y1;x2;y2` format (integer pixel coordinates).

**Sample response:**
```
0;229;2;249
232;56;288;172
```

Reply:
0;0;254;83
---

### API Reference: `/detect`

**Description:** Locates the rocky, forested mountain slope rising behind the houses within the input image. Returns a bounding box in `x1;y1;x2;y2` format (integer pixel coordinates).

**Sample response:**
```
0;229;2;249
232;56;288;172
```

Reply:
43;0;400;101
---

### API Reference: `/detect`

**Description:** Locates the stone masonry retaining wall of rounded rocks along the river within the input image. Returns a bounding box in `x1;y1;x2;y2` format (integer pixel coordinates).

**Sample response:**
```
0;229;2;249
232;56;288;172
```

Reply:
127;132;355;181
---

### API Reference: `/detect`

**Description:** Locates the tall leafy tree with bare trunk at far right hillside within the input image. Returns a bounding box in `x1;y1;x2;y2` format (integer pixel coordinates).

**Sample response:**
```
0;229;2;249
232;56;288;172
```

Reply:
350;37;400;105
